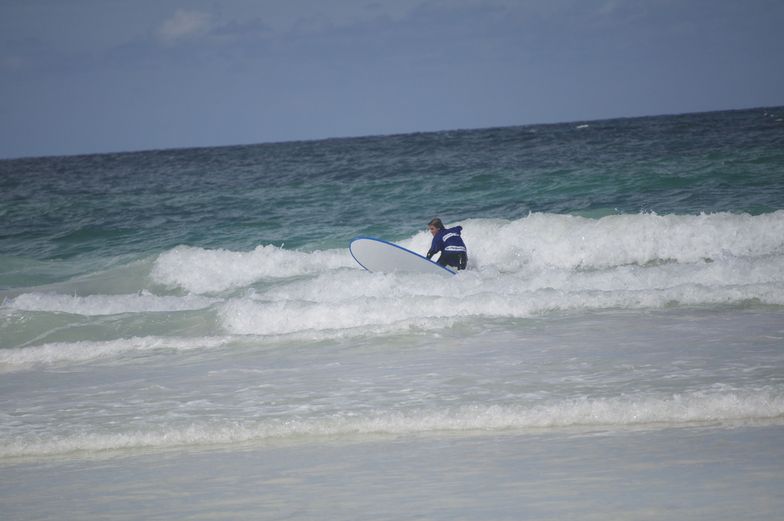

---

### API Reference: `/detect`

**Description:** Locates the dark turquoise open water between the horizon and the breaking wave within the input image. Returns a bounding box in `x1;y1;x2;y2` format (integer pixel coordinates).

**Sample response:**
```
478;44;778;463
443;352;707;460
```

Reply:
0;109;784;260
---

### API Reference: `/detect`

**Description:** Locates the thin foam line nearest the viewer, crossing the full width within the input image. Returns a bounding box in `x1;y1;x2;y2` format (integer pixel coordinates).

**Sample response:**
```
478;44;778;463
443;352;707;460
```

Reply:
0;390;784;458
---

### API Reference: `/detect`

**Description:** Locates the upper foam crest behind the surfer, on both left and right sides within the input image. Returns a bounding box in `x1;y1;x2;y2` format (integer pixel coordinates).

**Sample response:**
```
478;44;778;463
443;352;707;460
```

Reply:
151;210;784;293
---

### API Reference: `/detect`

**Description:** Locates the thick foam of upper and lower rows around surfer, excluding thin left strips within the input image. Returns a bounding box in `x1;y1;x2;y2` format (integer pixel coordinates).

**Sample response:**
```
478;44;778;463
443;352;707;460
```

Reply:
144;211;784;338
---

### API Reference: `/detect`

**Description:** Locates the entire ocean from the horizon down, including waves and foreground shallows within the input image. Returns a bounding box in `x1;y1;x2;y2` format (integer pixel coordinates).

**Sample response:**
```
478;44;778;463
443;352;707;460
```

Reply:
0;107;784;521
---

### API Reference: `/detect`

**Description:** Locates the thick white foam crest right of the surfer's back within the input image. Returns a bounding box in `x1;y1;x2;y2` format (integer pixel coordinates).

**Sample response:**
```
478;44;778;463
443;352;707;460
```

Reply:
463;210;784;271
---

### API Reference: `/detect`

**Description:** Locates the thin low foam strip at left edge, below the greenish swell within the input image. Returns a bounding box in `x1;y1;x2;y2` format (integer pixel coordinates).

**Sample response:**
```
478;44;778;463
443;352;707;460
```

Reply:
0;336;231;372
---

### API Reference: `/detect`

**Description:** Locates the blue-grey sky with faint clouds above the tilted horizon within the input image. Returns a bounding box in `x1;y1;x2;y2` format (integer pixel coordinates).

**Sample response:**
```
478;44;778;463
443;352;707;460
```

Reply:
0;0;784;158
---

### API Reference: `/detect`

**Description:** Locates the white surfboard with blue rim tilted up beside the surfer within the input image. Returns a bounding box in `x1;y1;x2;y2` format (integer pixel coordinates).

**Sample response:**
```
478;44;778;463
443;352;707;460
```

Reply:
348;237;455;275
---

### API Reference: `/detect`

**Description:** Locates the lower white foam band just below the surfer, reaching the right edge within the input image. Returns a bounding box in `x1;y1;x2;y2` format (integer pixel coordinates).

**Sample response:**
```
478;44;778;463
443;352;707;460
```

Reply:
219;280;784;338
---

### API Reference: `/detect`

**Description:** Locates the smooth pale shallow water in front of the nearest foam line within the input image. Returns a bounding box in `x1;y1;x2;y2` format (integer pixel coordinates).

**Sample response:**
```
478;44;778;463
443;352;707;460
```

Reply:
0;427;784;520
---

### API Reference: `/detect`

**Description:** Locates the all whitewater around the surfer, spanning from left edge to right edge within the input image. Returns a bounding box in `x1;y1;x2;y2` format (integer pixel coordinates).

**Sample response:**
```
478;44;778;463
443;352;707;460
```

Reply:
0;211;784;371
